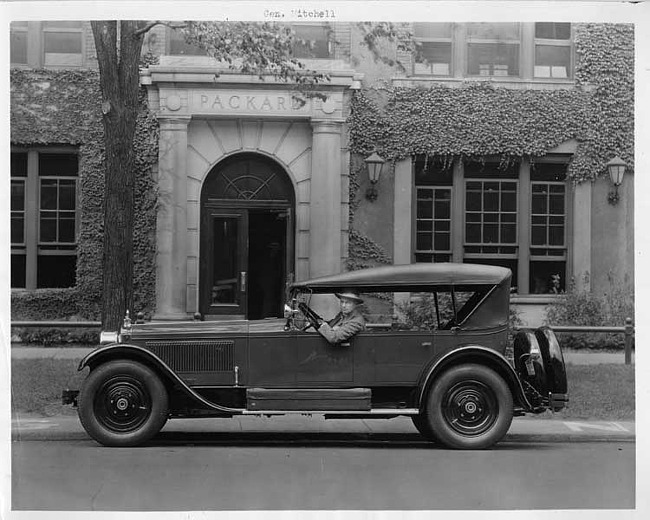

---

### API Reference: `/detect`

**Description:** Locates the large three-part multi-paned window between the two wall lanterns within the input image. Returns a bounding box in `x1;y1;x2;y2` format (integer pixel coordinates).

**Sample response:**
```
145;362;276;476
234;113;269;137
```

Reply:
413;157;569;294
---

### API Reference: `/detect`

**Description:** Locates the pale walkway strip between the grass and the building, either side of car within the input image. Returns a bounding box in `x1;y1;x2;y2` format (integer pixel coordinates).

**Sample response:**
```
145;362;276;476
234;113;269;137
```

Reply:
11;345;634;365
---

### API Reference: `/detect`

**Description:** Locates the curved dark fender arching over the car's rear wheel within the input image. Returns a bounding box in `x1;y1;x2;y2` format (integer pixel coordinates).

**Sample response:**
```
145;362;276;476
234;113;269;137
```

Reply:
418;345;533;412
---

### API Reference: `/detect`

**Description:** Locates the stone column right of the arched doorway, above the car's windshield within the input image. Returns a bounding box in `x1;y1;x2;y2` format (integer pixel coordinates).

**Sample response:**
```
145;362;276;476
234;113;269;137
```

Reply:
309;121;341;278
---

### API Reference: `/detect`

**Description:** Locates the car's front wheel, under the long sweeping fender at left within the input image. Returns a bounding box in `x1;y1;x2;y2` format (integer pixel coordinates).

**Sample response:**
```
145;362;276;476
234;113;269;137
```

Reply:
78;360;168;446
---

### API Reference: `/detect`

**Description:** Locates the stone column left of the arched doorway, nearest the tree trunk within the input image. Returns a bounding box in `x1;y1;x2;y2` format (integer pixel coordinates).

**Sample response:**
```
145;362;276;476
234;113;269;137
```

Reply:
154;117;190;320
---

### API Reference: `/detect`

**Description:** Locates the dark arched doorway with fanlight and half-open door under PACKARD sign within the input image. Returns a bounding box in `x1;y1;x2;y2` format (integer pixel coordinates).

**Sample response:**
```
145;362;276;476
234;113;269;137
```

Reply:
199;153;295;319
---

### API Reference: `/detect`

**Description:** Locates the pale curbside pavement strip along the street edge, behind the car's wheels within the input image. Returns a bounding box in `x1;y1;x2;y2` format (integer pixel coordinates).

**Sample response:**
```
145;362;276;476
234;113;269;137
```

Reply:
11;414;635;443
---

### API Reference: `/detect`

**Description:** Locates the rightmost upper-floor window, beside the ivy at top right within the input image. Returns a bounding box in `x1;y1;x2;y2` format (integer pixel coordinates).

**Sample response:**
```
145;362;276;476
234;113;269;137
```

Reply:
534;23;572;78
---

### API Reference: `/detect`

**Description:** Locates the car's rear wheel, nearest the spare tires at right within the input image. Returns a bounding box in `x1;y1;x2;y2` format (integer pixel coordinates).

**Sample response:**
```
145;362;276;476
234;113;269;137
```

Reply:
423;364;513;449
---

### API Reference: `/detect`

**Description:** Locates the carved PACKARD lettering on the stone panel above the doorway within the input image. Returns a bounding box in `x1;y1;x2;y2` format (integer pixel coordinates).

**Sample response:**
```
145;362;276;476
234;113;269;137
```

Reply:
191;91;311;115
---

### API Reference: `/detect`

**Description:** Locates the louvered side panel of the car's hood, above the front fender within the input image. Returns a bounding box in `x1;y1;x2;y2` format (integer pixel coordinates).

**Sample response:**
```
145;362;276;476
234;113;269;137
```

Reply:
146;341;235;372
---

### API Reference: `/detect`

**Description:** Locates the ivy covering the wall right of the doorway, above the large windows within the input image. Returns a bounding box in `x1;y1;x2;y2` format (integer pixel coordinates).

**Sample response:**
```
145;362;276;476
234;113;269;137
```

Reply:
348;24;634;268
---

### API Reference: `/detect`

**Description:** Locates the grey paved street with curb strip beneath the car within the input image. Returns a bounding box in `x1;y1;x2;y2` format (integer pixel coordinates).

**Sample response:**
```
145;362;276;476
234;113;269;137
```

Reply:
12;416;635;510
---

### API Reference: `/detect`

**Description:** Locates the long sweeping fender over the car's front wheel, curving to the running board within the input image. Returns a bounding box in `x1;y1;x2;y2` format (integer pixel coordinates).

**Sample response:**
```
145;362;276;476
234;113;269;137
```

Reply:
77;344;243;414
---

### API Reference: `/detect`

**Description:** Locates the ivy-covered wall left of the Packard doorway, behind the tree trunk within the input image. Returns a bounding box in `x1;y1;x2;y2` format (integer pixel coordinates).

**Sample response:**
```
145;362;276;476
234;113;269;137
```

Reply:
11;69;158;319
